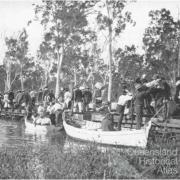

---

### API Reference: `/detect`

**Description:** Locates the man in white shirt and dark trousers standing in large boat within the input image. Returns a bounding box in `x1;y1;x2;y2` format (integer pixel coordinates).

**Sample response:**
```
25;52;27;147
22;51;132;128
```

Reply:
117;89;132;130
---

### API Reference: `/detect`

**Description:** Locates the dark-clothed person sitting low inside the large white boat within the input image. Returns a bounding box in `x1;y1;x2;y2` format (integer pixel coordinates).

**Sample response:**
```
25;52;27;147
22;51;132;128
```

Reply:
101;113;114;131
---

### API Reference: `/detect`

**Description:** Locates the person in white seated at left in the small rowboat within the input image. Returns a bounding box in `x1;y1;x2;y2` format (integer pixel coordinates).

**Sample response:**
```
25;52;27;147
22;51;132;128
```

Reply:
33;106;51;125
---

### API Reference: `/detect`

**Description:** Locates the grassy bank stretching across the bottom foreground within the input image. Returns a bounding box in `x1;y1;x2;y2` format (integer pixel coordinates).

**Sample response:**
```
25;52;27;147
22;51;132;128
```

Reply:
0;142;179;179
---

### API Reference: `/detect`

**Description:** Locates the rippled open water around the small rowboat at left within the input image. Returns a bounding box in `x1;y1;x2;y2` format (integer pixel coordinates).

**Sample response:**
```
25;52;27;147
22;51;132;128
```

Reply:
0;119;67;146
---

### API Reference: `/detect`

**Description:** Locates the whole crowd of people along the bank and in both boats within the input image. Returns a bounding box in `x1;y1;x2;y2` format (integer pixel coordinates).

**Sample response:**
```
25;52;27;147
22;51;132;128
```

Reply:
0;75;180;130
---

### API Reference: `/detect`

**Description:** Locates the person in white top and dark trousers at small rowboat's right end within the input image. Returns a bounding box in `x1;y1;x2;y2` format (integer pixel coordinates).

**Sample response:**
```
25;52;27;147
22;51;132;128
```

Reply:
47;97;64;125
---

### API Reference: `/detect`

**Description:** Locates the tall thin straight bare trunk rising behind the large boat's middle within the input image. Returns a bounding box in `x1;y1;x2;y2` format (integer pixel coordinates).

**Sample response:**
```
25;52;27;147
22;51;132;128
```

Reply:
106;1;112;102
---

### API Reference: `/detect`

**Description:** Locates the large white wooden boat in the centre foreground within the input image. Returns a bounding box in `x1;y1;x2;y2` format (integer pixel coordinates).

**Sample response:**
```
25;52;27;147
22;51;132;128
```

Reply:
63;121;151;148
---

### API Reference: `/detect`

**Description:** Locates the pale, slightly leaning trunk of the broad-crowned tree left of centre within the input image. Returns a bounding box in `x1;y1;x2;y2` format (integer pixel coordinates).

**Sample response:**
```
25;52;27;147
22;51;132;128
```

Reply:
55;46;64;98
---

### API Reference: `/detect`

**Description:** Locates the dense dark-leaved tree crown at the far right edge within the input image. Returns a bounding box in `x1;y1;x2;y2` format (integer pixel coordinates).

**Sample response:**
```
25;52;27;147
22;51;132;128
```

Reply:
143;9;180;81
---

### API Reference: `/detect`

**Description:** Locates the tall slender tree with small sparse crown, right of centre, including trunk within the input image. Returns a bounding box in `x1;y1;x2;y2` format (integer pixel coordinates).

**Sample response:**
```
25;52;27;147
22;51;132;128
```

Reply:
97;0;134;101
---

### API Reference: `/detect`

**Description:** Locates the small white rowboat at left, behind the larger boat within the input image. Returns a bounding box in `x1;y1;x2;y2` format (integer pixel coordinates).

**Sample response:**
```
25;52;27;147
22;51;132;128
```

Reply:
25;118;63;134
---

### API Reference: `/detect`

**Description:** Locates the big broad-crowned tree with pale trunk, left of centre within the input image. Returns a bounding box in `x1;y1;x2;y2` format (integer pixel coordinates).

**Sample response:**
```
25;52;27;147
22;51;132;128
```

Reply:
35;0;97;97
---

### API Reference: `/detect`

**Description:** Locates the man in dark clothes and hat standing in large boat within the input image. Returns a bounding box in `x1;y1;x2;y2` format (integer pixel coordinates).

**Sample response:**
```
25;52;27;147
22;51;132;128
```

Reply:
134;83;151;129
